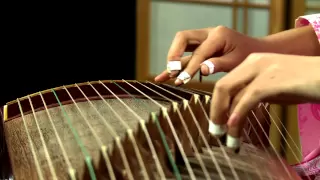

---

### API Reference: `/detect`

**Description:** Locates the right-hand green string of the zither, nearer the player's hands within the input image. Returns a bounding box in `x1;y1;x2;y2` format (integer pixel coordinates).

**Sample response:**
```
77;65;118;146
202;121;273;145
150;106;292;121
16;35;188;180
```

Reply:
112;81;182;180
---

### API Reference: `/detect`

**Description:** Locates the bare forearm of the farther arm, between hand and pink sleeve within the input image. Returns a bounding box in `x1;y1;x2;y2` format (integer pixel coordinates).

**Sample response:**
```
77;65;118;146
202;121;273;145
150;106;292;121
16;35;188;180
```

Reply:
263;25;320;56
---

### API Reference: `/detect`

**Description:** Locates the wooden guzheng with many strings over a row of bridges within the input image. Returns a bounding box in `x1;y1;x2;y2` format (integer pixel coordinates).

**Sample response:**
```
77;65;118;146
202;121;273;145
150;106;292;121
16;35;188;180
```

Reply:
0;80;296;180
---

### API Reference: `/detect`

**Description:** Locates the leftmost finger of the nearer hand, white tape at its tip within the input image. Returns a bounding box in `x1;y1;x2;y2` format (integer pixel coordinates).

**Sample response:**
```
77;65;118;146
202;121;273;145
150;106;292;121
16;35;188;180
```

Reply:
209;60;257;141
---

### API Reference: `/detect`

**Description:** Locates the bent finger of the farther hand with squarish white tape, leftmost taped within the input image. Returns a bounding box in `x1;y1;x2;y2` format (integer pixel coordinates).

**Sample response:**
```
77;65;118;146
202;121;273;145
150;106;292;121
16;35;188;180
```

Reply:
167;29;208;73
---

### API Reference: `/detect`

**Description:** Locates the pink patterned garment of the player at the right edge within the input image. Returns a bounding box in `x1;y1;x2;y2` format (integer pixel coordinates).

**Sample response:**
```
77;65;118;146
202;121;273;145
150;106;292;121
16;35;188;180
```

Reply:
293;14;320;180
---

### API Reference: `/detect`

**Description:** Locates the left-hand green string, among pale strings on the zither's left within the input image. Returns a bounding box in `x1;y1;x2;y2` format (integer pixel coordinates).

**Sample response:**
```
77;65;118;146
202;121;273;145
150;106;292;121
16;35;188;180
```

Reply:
51;89;97;180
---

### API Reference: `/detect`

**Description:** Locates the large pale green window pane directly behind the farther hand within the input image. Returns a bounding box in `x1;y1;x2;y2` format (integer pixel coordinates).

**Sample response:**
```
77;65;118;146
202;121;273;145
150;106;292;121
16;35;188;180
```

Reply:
149;1;232;78
